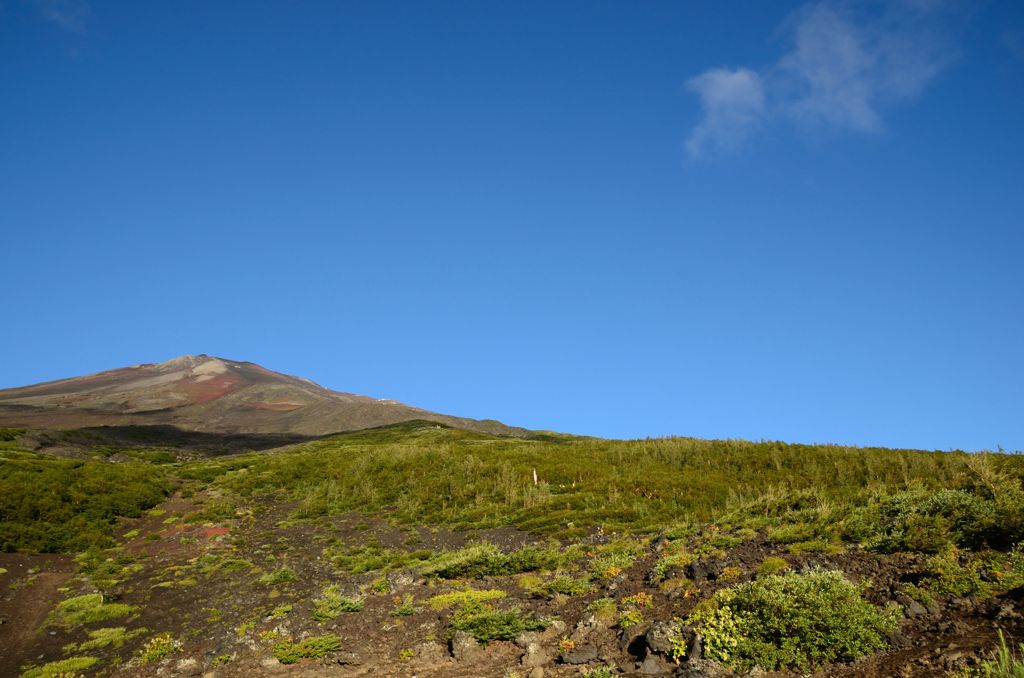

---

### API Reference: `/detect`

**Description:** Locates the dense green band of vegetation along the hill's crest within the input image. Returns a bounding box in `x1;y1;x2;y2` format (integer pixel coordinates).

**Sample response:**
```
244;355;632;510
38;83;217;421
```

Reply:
187;422;983;536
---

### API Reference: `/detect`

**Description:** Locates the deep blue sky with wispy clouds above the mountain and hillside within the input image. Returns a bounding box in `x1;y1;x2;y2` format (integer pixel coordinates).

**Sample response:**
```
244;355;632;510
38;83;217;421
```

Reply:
0;0;1024;450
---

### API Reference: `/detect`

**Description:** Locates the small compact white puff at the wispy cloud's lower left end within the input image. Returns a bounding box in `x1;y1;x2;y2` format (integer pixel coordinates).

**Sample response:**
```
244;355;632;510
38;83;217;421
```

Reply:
686;69;765;158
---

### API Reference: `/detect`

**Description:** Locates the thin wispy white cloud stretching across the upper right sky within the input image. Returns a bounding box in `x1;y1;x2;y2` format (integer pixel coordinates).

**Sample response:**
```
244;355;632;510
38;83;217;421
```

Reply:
686;0;955;159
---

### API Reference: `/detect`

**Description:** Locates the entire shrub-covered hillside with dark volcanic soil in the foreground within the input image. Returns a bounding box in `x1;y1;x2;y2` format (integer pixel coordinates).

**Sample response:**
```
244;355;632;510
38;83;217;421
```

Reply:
0;422;1024;678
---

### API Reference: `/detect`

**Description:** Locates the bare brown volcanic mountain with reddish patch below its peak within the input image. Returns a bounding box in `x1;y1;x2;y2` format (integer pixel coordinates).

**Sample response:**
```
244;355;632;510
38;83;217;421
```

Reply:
0;355;527;435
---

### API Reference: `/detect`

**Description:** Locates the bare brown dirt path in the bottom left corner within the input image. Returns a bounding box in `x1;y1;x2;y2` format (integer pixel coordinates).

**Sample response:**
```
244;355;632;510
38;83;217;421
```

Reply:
0;553;75;676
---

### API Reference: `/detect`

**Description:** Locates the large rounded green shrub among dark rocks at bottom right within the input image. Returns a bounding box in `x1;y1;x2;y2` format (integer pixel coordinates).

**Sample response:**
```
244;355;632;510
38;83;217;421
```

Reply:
688;570;897;671
